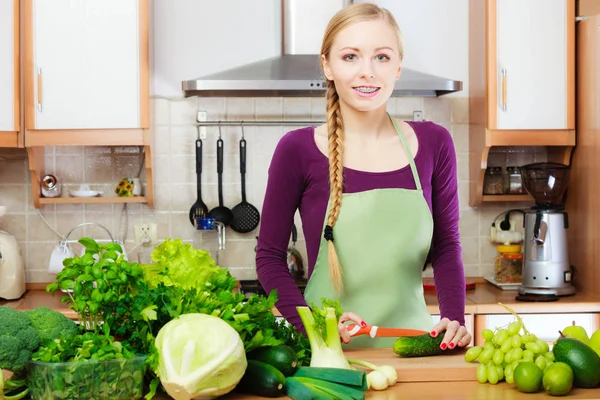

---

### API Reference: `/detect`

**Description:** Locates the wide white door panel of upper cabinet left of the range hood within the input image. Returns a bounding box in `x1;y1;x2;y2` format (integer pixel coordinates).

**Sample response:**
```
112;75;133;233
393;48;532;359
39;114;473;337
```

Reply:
29;0;143;129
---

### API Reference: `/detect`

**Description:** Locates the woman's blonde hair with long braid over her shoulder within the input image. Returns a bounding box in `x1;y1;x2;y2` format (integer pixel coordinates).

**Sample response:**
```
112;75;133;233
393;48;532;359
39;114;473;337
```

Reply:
321;3;404;295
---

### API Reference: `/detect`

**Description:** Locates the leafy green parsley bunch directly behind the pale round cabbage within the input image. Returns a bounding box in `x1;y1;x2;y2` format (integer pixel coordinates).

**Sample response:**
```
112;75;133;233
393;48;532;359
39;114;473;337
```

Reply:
107;268;310;363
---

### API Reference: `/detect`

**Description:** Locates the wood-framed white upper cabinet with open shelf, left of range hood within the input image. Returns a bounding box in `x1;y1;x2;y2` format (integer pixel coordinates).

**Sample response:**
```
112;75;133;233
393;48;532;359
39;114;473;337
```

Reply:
22;0;153;207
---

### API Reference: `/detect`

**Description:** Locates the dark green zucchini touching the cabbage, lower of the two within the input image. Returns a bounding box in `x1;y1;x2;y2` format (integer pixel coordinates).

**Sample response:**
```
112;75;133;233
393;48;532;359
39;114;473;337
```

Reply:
236;360;285;397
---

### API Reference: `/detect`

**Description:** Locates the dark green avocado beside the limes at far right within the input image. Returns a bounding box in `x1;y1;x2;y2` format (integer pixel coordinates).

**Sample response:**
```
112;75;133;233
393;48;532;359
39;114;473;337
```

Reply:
552;337;600;388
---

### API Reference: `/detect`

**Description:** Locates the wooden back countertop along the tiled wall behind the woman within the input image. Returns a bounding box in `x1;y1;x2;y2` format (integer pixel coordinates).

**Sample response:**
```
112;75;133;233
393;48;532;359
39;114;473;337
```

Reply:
0;281;600;319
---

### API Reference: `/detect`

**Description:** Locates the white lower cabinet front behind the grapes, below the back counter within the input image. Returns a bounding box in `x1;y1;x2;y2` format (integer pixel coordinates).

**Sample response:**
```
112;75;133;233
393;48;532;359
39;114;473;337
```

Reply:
486;313;599;344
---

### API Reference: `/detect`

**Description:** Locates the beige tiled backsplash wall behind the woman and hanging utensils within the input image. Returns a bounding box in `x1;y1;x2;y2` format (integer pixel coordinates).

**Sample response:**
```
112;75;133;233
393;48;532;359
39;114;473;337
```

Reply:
0;97;536;282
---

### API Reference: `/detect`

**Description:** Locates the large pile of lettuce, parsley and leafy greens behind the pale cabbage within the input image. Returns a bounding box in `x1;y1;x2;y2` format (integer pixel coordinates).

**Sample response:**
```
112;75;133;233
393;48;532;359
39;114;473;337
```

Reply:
47;238;311;399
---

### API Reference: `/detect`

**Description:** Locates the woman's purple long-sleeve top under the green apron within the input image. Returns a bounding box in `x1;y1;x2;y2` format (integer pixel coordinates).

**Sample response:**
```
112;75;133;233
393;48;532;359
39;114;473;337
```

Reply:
256;122;466;332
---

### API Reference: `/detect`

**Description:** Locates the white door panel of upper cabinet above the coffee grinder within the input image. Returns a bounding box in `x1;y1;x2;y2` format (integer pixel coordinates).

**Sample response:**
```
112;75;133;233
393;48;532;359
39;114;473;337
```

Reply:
492;0;567;129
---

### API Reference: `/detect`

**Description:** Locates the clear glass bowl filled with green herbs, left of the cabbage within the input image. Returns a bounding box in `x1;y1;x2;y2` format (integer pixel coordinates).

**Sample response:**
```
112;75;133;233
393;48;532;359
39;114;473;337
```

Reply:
29;324;145;400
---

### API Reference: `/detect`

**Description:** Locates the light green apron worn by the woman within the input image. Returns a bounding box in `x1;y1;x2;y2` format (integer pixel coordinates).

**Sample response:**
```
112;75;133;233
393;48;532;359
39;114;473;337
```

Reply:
304;117;434;348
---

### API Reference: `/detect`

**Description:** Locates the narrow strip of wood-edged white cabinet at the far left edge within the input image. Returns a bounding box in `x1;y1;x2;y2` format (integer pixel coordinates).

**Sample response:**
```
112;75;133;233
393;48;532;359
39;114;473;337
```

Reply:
0;0;23;147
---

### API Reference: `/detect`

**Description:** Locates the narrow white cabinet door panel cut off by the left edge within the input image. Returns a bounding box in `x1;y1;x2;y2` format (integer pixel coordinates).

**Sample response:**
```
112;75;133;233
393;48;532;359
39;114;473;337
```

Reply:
0;0;16;131
